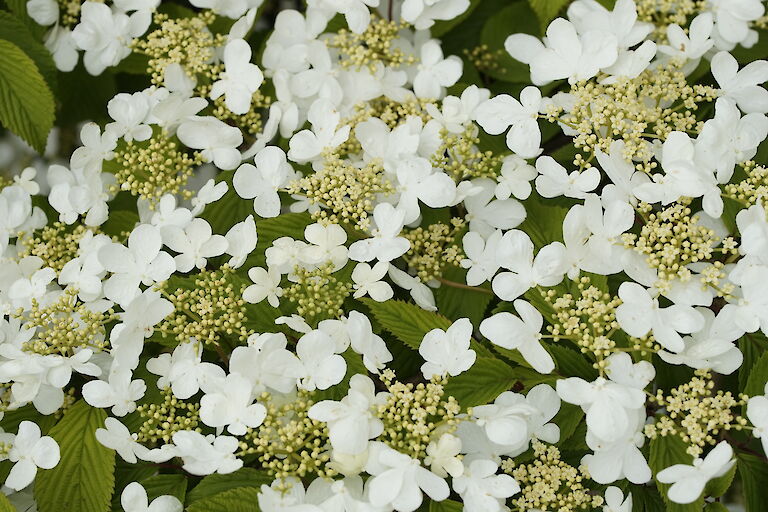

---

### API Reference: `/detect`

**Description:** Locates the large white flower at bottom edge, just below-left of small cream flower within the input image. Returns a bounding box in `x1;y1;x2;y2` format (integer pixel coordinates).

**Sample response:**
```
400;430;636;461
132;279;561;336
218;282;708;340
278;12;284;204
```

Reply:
366;442;450;512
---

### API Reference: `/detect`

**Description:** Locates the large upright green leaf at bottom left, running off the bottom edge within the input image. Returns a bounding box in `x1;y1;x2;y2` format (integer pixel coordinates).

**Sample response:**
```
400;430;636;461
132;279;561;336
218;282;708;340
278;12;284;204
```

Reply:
35;400;115;512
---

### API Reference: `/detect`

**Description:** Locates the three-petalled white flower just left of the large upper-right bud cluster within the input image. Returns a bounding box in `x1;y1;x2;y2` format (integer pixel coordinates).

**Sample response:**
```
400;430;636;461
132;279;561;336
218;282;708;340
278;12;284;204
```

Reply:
475;86;542;158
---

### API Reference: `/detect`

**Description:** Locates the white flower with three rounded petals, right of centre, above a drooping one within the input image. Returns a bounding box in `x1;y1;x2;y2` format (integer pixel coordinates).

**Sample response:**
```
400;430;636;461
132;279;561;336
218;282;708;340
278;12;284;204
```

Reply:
493;229;566;300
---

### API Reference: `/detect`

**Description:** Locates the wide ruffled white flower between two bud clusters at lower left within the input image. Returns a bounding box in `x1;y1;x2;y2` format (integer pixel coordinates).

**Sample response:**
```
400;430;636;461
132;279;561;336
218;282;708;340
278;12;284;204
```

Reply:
173;430;243;476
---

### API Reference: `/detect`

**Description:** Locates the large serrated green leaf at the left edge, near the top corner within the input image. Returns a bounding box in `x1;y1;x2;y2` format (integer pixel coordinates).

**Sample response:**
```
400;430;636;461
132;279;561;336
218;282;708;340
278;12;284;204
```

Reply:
0;40;55;153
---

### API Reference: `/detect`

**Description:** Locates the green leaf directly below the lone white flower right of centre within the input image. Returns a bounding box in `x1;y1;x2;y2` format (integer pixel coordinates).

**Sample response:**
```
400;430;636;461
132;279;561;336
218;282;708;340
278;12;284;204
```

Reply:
445;357;520;408
